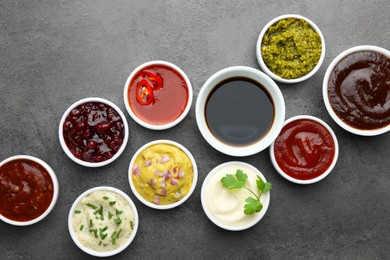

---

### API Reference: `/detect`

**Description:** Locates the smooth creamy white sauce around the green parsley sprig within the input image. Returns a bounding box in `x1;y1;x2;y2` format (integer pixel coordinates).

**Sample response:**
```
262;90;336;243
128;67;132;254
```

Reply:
203;164;265;227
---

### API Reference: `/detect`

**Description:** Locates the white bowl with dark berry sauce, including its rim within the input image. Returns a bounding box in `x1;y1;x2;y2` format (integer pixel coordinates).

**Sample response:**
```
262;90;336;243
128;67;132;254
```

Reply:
59;98;129;167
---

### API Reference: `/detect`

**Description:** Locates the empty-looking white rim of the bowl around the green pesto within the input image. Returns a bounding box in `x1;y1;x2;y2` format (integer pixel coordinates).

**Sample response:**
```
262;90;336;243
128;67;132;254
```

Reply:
256;14;325;84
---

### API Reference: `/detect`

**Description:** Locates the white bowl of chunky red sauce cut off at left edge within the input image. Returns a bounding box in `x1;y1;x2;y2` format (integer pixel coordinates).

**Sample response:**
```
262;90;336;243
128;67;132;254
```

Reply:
0;155;58;226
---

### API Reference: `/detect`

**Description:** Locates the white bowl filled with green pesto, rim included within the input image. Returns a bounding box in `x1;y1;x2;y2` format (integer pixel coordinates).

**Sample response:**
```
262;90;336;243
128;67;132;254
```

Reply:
256;14;325;83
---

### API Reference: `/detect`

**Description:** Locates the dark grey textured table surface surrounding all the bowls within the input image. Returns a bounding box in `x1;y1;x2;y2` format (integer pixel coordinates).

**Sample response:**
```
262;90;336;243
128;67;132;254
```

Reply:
0;0;390;259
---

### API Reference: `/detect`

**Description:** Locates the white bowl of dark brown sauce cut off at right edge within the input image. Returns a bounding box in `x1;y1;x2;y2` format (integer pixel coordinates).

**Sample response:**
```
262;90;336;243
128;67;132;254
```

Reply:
323;45;390;136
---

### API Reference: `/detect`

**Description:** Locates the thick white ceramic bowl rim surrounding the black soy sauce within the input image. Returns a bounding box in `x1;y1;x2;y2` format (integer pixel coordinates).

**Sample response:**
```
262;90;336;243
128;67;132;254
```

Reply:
195;66;286;157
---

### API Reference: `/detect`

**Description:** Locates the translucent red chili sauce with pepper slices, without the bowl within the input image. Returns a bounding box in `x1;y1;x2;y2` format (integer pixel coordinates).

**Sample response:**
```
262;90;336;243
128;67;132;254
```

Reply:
128;64;188;125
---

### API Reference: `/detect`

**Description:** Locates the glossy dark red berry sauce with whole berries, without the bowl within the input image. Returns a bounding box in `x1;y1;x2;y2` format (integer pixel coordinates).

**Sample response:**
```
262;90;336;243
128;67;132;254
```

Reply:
63;102;125;162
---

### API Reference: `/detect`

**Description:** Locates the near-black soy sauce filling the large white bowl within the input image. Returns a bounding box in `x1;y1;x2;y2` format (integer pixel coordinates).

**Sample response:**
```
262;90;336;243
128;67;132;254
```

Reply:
205;77;275;146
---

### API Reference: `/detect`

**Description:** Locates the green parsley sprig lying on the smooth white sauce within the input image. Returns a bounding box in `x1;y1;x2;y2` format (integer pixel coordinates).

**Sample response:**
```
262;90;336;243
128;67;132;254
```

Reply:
221;169;272;215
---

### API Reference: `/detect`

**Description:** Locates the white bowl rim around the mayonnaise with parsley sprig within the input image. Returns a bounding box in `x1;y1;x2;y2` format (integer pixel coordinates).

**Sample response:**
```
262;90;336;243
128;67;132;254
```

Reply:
201;161;271;231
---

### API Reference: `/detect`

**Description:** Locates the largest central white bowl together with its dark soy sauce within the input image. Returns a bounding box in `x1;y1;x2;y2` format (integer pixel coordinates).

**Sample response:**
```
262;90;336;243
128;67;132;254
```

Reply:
195;66;285;156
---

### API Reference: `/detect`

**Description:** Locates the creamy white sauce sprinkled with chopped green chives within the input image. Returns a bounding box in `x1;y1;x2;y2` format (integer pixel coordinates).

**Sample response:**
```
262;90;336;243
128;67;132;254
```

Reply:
72;190;135;252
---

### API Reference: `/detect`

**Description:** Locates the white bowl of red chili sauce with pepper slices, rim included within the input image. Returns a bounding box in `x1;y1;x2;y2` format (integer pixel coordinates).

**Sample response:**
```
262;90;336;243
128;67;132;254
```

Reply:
123;61;193;130
